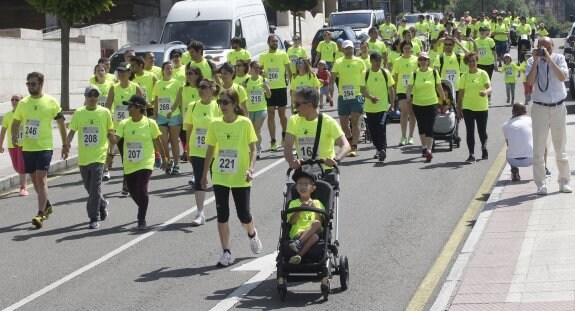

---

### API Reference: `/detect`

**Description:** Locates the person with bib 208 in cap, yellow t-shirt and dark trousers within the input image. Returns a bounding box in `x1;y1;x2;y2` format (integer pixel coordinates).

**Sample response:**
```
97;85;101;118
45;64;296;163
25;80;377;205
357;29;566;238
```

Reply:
67;86;114;229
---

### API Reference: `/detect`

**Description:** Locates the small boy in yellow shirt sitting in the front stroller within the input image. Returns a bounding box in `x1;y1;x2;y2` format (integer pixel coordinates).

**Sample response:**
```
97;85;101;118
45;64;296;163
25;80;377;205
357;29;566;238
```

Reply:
287;170;325;264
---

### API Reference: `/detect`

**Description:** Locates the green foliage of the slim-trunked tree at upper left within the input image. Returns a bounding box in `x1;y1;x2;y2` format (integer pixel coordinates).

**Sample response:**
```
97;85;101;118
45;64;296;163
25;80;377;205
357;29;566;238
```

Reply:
26;0;114;23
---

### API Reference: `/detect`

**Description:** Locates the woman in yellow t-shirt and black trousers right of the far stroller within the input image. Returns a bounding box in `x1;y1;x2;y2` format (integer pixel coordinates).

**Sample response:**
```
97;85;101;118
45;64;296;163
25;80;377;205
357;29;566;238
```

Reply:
457;52;491;163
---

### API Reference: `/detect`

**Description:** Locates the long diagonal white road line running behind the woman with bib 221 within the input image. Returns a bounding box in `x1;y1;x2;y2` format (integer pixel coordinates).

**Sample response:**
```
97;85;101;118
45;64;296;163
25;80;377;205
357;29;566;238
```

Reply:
3;158;285;311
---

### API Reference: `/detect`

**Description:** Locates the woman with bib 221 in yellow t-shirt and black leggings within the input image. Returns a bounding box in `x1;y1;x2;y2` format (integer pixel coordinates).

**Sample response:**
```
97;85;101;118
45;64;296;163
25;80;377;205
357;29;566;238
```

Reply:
202;90;262;267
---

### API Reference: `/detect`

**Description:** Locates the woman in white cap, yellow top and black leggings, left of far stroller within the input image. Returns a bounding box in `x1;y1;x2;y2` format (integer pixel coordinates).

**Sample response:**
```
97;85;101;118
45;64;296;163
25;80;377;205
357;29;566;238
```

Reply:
407;52;445;163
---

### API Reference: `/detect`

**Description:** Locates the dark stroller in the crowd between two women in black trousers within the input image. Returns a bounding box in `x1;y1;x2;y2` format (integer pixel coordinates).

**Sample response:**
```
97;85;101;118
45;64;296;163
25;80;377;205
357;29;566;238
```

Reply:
432;79;461;151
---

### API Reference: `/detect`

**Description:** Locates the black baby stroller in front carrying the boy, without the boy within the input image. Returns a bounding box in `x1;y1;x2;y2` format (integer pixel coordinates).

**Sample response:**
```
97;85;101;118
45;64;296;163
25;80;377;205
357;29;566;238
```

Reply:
276;160;349;301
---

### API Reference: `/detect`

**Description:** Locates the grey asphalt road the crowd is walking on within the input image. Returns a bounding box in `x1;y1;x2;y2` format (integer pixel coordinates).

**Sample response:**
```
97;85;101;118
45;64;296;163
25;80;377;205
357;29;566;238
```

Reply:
0;47;573;310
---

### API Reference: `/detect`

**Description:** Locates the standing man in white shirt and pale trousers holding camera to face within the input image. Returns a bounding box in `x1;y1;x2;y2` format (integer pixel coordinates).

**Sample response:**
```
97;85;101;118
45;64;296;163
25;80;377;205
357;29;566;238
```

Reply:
525;37;573;195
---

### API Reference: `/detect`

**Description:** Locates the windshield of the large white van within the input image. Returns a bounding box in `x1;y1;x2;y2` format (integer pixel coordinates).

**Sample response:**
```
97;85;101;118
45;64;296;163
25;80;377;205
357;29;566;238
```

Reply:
162;20;232;50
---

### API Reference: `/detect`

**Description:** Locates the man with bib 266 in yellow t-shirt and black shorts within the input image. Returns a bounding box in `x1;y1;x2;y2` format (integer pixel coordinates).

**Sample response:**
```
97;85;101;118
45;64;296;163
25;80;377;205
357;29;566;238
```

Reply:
260;35;292;151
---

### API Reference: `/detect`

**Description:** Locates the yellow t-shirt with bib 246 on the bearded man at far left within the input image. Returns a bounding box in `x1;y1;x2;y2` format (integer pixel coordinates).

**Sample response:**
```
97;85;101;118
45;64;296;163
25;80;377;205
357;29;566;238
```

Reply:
13;94;62;151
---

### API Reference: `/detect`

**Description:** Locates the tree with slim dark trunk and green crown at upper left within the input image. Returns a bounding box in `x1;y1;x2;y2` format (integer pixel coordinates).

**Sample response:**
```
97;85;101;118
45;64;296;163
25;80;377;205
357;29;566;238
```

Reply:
26;0;114;110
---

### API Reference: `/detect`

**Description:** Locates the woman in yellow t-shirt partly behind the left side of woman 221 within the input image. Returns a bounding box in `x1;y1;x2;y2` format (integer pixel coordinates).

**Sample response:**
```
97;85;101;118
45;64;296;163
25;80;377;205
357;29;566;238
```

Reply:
184;79;222;226
